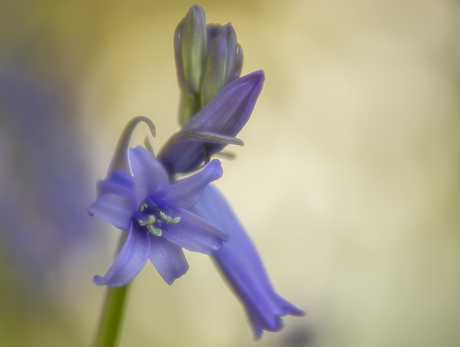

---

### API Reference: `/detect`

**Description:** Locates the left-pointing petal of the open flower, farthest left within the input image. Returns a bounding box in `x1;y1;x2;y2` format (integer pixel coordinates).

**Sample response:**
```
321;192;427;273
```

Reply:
86;188;136;230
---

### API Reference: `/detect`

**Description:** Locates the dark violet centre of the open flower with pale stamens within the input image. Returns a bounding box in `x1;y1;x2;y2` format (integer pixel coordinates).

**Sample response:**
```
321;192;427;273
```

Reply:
134;198;180;236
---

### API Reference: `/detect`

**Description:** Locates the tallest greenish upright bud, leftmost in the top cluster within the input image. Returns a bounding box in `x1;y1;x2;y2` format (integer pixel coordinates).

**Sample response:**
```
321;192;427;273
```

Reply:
174;5;208;94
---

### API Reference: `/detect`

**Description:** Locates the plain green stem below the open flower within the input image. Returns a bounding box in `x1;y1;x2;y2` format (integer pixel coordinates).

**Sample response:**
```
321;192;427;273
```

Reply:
93;237;130;347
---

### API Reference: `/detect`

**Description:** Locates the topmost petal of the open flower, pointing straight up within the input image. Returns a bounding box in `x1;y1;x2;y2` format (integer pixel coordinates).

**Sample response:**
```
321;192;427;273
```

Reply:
129;146;169;206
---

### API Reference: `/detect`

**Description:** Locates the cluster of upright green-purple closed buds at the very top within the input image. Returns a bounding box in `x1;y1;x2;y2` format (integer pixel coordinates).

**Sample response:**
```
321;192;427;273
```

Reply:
174;5;243;127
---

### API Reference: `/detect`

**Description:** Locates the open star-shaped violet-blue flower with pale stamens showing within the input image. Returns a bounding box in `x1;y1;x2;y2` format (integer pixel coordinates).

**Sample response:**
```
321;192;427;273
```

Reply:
88;147;228;287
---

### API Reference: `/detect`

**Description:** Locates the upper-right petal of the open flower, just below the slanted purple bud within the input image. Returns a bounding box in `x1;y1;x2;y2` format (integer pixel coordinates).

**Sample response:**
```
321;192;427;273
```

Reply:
163;160;223;210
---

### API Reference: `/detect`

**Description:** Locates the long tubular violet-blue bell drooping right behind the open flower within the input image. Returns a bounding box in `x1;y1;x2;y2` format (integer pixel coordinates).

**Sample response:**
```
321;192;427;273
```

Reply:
191;186;304;339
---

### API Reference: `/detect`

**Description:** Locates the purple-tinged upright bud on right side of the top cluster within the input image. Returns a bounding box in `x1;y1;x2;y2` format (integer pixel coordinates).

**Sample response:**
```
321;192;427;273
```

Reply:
201;23;242;105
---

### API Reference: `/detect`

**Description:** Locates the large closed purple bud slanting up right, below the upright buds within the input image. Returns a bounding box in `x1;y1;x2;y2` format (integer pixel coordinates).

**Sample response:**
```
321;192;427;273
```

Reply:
158;71;265;173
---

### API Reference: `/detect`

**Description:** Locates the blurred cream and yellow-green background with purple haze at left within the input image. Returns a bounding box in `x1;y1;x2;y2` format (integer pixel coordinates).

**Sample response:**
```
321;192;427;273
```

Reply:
0;0;460;347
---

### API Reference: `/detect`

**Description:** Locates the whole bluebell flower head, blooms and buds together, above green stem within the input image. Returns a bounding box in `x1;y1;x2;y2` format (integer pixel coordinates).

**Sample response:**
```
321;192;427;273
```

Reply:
87;5;304;339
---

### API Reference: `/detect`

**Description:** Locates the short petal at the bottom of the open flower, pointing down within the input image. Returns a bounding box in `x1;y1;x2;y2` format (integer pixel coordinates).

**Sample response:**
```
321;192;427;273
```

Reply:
149;236;188;285
